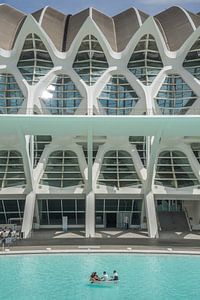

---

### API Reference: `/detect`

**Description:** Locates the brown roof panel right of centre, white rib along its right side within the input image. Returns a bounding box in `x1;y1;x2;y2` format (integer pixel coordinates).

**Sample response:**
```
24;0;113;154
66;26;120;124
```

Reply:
113;8;148;52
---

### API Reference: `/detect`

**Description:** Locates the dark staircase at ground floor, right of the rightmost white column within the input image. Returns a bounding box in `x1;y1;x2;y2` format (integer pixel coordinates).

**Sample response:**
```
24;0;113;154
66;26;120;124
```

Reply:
157;211;190;231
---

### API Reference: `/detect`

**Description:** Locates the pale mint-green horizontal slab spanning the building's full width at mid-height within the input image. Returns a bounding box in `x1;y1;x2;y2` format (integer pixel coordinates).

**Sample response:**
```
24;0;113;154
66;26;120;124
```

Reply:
0;115;200;137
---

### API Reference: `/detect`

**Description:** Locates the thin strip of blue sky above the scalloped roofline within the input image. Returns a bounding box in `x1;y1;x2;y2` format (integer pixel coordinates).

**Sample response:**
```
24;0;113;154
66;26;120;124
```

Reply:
0;0;200;16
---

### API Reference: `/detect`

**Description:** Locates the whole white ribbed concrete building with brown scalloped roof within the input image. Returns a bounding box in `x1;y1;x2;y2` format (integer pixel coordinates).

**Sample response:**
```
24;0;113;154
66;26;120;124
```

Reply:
0;4;200;238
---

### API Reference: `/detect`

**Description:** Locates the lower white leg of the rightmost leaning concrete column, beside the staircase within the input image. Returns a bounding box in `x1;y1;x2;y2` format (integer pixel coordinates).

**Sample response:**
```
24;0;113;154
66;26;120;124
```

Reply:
144;191;158;238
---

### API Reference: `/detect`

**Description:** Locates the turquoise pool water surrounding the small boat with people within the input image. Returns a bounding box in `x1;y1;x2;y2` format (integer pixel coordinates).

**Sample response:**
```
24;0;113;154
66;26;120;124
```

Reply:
0;254;200;300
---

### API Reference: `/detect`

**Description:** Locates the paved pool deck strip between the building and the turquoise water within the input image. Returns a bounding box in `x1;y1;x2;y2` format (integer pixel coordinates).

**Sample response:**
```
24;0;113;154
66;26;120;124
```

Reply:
0;229;200;255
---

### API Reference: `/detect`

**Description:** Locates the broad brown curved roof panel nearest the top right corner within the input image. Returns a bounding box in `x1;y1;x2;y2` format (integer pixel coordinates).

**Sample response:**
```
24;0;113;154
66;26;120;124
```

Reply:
154;6;194;51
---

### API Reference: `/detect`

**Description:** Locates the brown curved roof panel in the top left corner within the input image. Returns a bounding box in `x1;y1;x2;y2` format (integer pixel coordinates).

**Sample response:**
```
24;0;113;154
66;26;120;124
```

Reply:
0;4;26;50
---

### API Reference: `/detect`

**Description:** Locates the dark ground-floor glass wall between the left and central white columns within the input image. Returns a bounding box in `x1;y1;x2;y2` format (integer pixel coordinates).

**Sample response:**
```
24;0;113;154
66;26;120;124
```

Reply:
38;199;85;227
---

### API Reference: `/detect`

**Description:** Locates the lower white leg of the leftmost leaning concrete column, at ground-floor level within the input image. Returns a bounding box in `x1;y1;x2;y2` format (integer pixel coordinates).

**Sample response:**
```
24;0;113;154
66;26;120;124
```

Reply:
22;191;36;239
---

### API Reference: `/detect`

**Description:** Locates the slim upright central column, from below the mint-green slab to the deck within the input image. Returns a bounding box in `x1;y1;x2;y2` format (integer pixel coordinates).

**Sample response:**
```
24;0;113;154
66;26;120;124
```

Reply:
85;129;95;237
